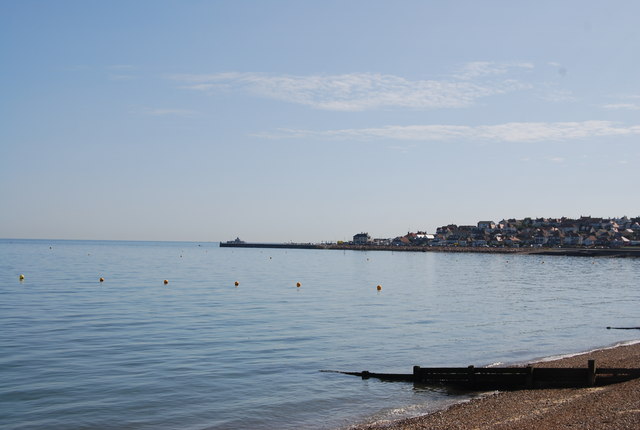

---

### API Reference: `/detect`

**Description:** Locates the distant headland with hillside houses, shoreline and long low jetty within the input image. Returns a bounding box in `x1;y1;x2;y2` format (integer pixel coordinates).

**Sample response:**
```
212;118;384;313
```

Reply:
220;216;640;256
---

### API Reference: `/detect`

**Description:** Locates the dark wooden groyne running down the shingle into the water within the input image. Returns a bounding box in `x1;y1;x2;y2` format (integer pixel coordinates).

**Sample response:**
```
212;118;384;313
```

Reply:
328;360;640;390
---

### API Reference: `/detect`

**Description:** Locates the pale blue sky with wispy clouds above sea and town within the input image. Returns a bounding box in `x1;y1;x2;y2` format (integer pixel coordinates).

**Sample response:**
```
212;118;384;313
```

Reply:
0;0;640;242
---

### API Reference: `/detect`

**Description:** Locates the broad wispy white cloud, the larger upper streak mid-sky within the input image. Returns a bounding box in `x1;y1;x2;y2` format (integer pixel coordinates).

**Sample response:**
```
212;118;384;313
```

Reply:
169;62;533;111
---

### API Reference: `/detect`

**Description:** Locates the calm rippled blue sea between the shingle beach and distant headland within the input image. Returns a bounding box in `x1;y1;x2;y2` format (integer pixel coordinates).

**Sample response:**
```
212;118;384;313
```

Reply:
0;240;640;429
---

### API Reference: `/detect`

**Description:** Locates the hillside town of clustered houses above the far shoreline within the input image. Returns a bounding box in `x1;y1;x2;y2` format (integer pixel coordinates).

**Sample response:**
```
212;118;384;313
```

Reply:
352;216;640;248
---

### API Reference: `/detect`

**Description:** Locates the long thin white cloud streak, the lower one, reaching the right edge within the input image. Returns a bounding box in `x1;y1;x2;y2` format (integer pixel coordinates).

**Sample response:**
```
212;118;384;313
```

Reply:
254;121;640;142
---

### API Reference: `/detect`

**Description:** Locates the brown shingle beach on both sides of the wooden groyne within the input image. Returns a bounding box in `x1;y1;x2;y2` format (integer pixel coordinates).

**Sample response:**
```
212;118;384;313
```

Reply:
351;343;640;430
